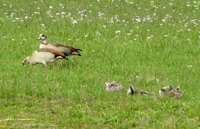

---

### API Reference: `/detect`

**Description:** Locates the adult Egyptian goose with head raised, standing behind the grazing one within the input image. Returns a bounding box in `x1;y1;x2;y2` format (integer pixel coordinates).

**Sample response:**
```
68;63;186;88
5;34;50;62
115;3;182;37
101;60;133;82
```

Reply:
38;34;82;56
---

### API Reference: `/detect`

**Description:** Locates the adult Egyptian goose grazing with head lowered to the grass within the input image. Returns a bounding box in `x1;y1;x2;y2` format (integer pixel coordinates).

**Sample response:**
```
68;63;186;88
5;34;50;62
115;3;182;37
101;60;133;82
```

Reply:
22;48;67;67
